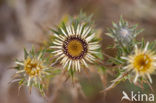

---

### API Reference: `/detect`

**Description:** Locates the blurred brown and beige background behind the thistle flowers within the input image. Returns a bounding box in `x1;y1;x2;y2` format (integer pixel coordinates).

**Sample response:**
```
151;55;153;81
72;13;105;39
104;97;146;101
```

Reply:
0;0;156;103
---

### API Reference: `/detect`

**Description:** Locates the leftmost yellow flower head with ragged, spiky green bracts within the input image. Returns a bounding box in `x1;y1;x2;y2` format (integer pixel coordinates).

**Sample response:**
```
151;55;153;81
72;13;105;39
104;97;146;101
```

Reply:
13;49;50;91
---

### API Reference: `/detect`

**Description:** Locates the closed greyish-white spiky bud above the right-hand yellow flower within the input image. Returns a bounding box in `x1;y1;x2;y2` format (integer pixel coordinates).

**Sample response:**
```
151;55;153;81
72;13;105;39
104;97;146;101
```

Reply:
107;17;142;45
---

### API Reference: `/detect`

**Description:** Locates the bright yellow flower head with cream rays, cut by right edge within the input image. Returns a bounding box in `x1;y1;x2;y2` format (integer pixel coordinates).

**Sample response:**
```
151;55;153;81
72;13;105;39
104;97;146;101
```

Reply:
122;43;156;83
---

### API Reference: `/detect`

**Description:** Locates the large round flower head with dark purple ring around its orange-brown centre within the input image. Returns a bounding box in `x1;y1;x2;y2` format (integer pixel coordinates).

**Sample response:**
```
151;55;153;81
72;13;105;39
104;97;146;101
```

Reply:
50;14;100;71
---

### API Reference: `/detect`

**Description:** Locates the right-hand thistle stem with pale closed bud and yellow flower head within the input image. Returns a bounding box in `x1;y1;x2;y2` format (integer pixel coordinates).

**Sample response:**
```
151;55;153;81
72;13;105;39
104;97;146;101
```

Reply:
105;17;156;90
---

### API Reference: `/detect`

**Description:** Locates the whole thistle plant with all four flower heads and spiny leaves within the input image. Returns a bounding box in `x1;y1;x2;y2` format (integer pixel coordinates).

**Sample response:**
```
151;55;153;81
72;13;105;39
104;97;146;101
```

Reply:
9;12;156;100
